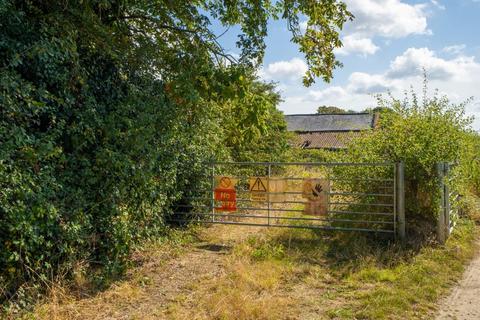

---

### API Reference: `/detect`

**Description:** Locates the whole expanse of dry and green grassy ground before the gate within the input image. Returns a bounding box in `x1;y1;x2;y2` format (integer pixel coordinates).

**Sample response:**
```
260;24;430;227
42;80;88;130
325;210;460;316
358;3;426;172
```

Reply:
13;215;476;320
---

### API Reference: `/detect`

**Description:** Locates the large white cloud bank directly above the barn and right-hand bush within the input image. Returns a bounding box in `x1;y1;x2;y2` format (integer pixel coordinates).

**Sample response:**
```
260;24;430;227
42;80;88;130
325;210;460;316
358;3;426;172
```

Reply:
280;48;480;129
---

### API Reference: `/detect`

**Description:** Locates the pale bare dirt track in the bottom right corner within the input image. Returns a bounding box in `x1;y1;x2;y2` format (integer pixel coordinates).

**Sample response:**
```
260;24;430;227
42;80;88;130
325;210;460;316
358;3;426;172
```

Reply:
436;242;480;320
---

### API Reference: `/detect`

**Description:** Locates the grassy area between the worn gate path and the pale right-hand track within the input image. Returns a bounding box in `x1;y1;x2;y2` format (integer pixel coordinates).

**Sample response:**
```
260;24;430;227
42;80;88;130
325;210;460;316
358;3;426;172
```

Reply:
169;221;477;319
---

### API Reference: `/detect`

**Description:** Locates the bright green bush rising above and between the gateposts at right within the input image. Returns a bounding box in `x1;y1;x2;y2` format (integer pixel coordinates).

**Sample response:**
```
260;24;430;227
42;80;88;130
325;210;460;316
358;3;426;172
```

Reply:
329;82;480;228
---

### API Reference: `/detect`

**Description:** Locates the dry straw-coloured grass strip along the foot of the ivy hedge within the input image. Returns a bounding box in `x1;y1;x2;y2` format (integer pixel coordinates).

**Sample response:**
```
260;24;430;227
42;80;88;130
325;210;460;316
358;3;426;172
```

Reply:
12;228;198;320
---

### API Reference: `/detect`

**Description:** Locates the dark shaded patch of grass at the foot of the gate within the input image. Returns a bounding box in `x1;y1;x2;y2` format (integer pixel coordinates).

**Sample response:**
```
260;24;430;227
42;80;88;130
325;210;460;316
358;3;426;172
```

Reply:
252;229;426;276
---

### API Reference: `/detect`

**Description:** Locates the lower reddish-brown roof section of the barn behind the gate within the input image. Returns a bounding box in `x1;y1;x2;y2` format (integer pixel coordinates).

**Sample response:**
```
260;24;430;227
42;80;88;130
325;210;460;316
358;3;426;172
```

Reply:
294;131;361;149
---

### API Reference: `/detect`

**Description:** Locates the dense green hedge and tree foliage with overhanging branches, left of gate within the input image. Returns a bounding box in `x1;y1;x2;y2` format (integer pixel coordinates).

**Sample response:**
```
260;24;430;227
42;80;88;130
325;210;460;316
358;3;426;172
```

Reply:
0;0;352;302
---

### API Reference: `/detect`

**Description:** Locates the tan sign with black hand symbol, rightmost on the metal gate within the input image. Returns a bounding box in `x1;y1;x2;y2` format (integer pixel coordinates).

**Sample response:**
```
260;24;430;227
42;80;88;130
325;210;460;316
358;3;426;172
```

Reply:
302;179;330;216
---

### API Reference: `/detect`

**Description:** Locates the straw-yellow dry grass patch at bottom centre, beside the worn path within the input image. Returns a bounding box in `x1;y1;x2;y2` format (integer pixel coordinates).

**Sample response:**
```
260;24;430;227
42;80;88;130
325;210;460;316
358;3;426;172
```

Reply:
168;261;293;320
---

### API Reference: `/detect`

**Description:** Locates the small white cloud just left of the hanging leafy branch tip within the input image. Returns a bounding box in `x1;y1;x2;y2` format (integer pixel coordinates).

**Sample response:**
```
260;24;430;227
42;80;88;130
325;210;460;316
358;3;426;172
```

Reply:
259;58;308;80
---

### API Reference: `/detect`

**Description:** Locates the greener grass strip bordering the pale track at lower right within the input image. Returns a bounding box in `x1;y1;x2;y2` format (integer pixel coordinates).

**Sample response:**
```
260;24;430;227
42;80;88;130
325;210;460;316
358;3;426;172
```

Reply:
328;222;477;319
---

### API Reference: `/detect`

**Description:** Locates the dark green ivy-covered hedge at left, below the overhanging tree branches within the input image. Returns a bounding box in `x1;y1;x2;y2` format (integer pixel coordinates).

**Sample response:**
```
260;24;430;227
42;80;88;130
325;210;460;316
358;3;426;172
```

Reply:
0;11;209;298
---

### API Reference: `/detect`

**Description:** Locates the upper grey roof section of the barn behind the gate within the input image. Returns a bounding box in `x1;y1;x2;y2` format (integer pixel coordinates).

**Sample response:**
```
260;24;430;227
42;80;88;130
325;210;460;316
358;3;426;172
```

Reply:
285;113;375;132
